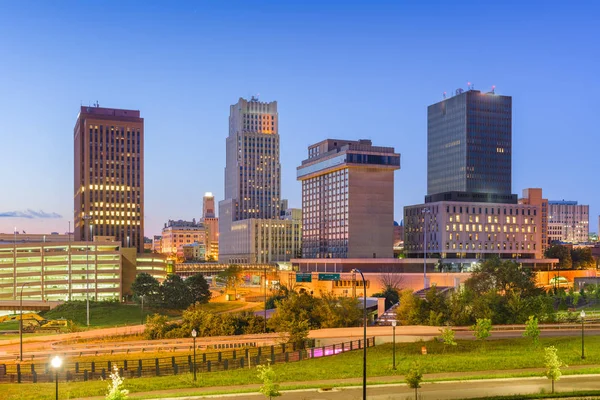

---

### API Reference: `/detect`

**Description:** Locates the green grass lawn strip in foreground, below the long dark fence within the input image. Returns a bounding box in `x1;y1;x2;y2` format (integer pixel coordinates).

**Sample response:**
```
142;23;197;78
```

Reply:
0;336;600;400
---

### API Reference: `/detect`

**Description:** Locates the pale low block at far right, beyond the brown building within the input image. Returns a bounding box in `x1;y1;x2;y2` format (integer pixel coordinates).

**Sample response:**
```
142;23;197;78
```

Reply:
548;200;590;243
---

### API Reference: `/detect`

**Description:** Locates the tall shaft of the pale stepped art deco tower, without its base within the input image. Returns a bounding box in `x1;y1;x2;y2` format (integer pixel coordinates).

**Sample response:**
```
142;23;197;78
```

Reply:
225;97;281;221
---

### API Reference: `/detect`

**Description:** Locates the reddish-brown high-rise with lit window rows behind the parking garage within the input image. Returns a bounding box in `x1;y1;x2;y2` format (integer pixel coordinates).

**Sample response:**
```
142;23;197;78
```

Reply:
74;105;144;253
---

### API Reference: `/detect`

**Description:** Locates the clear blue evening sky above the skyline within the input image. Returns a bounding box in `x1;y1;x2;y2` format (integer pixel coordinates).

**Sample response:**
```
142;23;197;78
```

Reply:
0;0;600;237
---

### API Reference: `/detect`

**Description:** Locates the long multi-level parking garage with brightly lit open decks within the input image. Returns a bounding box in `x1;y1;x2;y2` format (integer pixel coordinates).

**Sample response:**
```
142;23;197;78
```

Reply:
0;234;169;303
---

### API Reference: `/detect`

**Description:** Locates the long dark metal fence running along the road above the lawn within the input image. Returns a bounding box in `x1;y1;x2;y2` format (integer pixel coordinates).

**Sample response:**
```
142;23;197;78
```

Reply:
0;337;375;383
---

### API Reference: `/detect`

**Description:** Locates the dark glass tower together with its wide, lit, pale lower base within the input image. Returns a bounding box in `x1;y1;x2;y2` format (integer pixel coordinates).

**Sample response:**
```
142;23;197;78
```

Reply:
404;89;548;270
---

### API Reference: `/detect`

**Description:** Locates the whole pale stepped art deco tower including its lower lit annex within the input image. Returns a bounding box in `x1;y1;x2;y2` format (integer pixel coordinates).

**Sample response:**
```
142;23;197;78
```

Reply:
218;97;301;264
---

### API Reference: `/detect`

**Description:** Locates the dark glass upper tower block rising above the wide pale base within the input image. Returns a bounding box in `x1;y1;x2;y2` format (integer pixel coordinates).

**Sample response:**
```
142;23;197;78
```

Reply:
427;89;516;198
